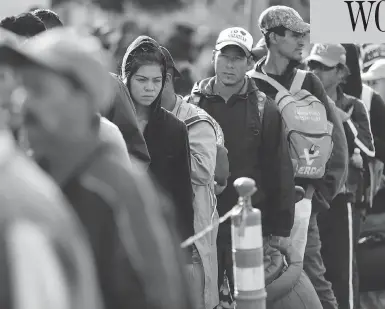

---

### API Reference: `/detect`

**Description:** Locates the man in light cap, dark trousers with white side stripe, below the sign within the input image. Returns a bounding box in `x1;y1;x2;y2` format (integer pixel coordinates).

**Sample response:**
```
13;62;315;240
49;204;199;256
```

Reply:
306;44;375;309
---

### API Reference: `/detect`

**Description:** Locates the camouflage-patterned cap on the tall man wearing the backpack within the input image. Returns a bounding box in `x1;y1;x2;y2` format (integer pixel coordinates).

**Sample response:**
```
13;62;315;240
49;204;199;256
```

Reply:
258;5;310;34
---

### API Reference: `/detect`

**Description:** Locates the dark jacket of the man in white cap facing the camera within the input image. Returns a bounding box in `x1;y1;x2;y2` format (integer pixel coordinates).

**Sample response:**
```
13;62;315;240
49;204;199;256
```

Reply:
192;77;294;237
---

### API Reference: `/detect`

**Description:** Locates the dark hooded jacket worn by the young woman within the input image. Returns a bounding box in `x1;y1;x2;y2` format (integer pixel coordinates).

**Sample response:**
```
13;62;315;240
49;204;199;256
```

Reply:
125;36;194;248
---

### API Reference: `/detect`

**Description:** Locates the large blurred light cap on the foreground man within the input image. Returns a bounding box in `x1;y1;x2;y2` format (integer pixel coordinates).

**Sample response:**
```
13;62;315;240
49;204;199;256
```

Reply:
0;28;114;111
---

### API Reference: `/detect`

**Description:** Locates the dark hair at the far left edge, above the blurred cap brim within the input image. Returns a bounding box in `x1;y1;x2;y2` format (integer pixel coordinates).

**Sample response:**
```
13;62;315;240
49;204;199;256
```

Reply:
0;12;46;38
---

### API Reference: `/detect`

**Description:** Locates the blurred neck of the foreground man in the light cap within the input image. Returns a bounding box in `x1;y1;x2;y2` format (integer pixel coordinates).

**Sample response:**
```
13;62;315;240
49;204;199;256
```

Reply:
37;134;101;185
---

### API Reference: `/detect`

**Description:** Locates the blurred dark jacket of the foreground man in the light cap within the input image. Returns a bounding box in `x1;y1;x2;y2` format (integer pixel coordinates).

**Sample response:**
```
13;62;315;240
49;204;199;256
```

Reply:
61;141;191;309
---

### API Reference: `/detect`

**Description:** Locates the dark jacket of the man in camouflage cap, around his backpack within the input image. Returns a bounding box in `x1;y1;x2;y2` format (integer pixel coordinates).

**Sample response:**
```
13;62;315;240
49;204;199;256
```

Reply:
254;57;348;209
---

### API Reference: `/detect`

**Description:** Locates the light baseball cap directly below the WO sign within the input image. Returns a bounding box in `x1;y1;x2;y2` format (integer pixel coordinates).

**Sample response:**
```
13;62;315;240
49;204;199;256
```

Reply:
306;44;346;67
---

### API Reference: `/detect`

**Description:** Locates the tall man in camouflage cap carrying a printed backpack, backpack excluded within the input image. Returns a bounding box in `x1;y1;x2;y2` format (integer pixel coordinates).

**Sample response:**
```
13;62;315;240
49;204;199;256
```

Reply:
248;5;347;308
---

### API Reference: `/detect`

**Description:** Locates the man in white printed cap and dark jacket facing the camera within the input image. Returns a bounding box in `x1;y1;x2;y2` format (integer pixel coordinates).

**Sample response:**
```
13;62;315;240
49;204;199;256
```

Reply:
189;27;295;304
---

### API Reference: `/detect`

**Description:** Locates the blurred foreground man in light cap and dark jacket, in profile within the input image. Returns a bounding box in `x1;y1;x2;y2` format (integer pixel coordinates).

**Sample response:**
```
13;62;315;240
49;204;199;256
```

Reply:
0;28;192;309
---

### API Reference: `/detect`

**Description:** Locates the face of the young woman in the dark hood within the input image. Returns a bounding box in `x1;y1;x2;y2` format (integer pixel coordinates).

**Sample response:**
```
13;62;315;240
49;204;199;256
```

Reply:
130;64;162;106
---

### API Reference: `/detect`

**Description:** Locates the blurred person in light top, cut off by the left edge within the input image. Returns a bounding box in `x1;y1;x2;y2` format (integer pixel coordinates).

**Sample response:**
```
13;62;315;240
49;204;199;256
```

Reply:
0;29;102;309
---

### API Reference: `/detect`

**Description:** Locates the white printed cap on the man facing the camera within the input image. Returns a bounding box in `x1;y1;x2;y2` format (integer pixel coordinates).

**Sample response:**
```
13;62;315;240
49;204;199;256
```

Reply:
215;27;253;55
